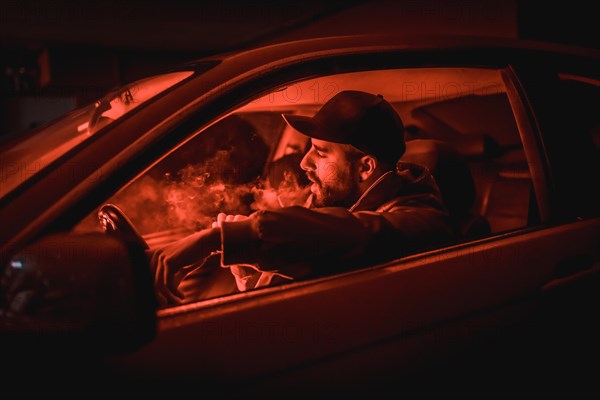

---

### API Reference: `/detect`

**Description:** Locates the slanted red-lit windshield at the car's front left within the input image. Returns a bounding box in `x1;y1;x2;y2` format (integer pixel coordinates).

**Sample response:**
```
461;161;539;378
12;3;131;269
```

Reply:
0;71;194;198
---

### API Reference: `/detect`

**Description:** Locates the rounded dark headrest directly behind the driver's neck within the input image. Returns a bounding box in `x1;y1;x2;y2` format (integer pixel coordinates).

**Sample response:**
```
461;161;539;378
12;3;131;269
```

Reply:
400;139;475;216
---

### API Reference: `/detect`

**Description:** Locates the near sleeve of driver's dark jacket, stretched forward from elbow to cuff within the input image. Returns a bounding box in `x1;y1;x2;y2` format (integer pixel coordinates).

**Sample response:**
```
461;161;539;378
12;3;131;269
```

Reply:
221;206;451;276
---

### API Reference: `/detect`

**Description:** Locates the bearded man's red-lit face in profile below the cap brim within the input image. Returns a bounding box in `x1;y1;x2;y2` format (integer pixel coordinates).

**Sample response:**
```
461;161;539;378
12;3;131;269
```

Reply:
300;139;360;207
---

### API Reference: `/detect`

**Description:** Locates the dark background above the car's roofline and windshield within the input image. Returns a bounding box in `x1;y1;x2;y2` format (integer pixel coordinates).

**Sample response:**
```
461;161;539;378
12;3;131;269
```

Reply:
0;0;599;138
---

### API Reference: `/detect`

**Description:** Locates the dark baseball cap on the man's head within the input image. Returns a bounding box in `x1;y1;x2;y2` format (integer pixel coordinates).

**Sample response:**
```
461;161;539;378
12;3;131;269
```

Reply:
282;90;406;164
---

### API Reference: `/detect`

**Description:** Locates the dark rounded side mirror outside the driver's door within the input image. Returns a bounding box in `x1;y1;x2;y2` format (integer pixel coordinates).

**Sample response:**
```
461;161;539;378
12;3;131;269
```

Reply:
0;233;157;355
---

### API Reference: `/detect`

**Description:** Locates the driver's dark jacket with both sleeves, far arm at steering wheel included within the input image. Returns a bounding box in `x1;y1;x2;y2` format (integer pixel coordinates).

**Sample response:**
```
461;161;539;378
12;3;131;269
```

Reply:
149;164;453;303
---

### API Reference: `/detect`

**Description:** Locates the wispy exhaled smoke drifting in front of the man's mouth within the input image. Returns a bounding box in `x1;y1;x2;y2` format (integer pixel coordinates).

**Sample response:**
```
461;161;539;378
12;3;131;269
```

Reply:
112;151;310;234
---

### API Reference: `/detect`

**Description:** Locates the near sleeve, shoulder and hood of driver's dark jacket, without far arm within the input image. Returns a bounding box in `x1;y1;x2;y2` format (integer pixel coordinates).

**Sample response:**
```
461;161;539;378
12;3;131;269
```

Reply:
221;164;453;286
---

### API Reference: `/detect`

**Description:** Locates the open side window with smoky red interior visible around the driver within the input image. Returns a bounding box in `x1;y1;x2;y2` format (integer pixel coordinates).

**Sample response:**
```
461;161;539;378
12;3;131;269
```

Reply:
77;68;539;308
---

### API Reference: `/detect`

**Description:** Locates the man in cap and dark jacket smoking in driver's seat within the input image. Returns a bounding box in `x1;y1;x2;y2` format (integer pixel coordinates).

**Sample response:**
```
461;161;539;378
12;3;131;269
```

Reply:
150;91;453;303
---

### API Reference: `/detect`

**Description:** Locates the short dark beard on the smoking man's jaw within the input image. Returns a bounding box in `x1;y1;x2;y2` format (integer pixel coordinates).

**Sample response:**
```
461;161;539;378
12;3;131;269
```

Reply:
307;172;360;208
